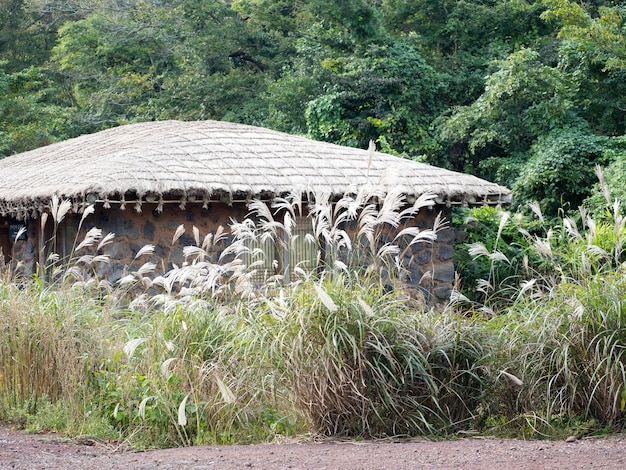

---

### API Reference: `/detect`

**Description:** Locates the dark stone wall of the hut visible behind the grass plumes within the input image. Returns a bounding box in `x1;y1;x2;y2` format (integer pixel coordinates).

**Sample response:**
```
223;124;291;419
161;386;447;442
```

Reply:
6;203;455;303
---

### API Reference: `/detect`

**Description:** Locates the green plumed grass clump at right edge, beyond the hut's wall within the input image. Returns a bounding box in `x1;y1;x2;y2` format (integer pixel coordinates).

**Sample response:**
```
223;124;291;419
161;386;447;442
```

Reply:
456;173;626;434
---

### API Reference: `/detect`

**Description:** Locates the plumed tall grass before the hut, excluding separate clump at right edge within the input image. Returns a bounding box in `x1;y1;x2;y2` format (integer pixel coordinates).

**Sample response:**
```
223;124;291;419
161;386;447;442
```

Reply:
0;193;484;446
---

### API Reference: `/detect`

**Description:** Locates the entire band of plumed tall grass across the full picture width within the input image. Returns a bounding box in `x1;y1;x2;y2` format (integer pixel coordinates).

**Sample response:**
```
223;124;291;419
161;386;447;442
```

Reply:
0;181;626;447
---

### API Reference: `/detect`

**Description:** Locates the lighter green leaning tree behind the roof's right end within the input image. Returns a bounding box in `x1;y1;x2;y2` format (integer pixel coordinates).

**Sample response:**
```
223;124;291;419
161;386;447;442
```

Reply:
440;49;581;185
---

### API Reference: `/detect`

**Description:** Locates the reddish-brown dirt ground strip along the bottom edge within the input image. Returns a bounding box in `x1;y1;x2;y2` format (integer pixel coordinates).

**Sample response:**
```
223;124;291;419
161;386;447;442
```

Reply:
0;424;626;470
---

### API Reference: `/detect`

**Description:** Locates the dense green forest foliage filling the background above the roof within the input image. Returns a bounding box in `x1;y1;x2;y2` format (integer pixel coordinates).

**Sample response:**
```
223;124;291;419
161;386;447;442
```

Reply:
0;0;626;216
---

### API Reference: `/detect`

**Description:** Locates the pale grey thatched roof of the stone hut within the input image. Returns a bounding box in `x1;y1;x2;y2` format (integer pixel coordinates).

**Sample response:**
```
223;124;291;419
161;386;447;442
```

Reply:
0;121;510;218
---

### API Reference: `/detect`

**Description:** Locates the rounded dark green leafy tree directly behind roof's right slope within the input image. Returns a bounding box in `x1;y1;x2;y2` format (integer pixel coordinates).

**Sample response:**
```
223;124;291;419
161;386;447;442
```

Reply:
306;41;438;156
